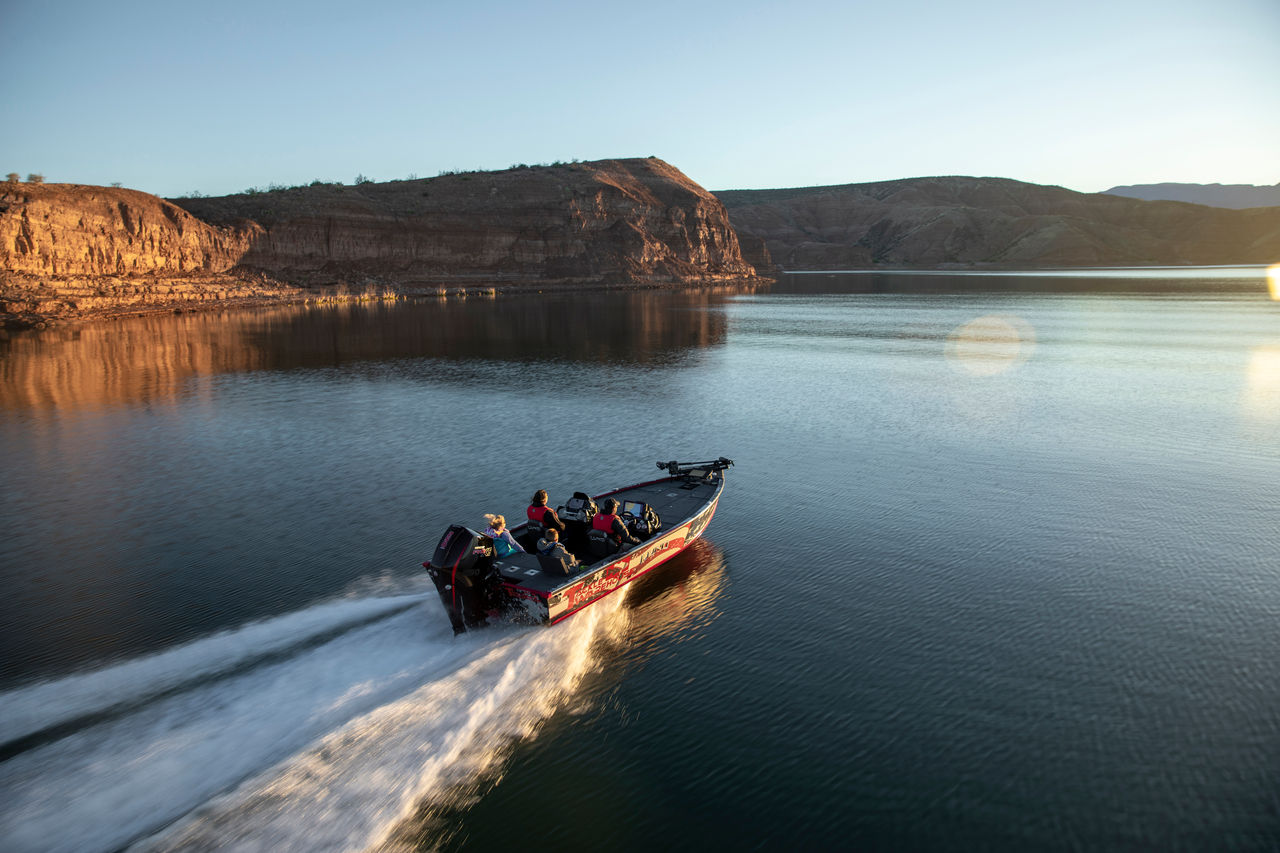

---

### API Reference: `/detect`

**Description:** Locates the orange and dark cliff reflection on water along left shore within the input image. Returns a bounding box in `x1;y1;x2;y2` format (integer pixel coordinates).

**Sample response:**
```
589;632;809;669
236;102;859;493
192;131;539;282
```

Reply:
0;288;739;409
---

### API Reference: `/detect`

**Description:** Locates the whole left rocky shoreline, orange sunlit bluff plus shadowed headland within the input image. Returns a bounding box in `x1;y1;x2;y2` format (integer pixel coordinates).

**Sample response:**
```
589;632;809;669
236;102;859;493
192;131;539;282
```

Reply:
0;158;759;325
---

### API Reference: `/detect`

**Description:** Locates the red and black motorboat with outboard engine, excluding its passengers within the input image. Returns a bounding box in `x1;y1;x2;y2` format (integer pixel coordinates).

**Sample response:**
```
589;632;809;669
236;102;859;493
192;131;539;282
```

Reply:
422;456;733;634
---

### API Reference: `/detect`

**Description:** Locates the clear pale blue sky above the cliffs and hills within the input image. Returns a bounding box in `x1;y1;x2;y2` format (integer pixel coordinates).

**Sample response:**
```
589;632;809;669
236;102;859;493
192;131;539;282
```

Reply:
0;0;1280;196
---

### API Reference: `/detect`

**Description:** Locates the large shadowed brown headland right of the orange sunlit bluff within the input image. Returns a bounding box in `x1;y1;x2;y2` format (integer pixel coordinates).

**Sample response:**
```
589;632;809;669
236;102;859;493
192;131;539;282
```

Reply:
178;159;754;283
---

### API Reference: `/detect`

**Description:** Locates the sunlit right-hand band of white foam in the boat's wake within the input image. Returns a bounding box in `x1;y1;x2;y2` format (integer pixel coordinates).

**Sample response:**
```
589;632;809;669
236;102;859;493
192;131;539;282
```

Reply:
138;597;621;852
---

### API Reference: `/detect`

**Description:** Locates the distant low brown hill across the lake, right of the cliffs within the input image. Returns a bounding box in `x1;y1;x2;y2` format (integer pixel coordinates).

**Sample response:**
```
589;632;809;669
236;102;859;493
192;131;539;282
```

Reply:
717;178;1280;269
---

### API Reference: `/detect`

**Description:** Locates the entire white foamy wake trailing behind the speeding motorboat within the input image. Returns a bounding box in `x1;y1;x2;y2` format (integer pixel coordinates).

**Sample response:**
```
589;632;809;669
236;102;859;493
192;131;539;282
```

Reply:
0;584;621;852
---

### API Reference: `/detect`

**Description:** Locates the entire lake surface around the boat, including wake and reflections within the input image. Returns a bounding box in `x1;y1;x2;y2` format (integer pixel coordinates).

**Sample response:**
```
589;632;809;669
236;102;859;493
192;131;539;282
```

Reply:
0;269;1280;852
